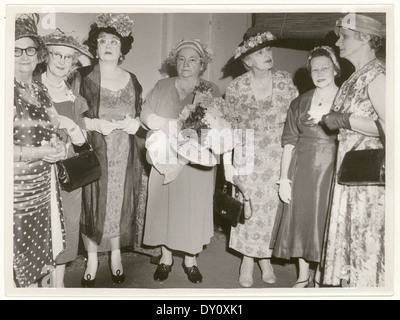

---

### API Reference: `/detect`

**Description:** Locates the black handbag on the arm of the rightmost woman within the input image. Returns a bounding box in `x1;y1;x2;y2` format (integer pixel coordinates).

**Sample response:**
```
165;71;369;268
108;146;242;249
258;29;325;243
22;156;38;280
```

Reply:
337;120;385;186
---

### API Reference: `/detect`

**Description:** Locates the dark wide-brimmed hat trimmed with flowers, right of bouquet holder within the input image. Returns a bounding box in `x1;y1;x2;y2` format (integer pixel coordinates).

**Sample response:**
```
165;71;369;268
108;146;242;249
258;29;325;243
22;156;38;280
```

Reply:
234;27;278;59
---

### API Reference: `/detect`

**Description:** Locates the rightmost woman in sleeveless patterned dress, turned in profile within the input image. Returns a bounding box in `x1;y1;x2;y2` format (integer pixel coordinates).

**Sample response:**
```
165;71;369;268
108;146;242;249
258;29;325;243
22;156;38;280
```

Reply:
322;14;386;287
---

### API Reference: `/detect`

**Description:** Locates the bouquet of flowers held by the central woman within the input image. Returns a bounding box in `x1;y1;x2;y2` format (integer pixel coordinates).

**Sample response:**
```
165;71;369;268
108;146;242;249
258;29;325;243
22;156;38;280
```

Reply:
179;83;235;154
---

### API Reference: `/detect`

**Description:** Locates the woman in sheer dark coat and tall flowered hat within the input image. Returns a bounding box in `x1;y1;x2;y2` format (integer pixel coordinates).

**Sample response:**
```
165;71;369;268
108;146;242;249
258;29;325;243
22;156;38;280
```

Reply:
73;13;144;287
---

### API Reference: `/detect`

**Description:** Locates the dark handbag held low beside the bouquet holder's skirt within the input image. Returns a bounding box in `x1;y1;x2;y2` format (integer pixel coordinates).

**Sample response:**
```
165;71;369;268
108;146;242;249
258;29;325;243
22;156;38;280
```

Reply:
214;181;245;227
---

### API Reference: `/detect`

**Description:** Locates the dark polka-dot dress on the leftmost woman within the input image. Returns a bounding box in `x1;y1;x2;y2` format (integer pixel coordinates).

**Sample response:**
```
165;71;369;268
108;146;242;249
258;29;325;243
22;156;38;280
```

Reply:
13;81;65;287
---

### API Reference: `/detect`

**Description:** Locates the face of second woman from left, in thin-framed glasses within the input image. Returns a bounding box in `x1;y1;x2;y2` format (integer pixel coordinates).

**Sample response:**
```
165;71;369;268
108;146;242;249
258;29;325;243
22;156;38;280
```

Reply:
47;46;75;78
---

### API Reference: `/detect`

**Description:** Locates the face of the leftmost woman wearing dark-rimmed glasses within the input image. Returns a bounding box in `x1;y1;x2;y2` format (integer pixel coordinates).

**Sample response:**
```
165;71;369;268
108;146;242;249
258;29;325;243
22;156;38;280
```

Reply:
14;37;38;80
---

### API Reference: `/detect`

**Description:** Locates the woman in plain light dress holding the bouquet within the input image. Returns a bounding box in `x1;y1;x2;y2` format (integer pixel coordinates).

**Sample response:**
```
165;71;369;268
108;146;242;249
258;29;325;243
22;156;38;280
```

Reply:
140;39;220;283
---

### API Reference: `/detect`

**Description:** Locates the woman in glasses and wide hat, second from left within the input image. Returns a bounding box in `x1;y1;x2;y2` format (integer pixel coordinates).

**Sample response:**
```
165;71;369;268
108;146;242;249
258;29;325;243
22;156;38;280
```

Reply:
38;29;93;288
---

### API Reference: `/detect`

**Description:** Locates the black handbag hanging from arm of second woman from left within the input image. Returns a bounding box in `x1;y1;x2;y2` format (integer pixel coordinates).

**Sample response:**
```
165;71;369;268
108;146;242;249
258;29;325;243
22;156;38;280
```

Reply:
57;132;101;192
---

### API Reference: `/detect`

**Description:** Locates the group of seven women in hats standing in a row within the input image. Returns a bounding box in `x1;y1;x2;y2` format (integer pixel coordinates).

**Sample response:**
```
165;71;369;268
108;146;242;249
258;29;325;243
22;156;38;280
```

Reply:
13;14;385;287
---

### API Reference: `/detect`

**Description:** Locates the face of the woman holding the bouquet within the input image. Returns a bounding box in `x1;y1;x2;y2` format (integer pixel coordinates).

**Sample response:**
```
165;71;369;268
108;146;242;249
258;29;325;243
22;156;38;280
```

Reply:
176;48;202;78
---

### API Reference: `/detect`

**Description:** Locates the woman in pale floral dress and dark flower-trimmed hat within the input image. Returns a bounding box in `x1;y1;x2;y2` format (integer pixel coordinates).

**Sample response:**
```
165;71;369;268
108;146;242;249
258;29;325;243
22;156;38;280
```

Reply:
224;28;298;287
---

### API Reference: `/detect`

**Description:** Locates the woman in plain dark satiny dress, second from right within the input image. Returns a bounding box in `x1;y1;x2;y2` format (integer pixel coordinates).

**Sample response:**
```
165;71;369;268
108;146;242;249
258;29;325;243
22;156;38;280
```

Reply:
271;46;340;288
